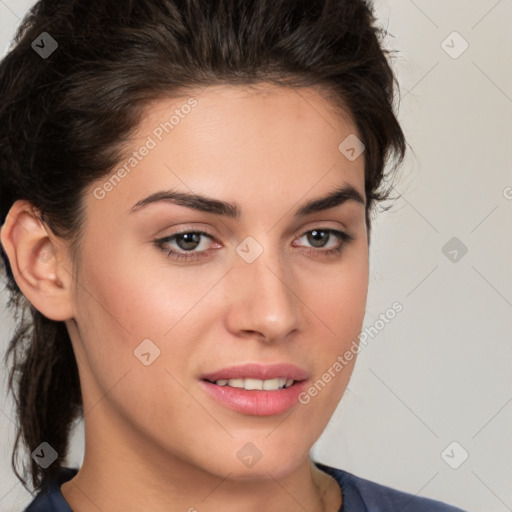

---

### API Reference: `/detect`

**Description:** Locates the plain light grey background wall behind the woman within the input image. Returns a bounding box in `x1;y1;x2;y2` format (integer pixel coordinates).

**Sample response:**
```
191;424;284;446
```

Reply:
0;0;512;512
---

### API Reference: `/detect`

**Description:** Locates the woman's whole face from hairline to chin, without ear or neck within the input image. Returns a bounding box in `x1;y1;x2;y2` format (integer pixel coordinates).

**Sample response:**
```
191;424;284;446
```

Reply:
67;85;368;479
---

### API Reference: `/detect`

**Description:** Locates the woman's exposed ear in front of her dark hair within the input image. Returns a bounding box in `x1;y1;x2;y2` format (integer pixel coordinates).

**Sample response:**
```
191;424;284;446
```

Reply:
0;200;74;321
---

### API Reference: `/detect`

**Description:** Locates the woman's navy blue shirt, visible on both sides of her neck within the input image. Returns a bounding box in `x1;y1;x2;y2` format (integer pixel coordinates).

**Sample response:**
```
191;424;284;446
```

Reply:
24;462;464;512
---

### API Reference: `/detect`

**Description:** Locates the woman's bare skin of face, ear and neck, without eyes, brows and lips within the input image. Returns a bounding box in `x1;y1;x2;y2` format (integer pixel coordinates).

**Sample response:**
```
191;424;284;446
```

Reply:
1;84;369;512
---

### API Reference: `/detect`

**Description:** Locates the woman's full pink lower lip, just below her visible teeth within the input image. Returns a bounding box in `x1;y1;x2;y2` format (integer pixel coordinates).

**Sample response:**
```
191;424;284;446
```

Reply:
201;380;307;416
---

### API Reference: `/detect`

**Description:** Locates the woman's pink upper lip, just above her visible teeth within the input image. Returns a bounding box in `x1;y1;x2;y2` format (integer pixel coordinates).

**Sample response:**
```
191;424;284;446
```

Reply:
201;363;309;382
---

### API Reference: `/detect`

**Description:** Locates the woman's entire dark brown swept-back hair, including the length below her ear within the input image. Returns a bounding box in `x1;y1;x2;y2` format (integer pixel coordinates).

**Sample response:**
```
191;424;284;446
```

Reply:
0;0;406;489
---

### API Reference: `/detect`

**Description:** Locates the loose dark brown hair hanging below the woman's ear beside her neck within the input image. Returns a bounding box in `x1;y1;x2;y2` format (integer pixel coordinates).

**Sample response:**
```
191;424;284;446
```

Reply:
5;296;82;489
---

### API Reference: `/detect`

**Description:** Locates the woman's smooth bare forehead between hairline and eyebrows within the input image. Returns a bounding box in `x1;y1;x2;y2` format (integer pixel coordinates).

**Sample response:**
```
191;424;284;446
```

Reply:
85;84;364;222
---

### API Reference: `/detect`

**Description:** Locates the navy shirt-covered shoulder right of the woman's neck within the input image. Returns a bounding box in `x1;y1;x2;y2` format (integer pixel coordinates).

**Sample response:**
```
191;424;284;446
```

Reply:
315;462;464;512
